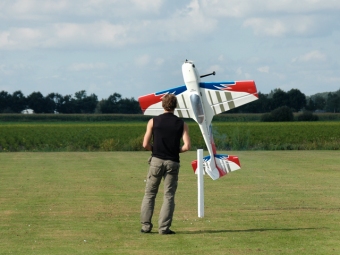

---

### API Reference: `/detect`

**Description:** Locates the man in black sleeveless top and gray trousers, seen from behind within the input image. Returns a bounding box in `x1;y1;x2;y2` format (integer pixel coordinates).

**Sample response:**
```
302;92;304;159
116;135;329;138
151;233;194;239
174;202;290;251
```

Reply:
141;94;191;234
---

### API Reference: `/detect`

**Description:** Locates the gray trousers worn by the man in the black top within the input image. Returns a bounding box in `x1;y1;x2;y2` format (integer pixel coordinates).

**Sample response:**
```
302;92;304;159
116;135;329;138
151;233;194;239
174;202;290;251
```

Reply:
141;157;179;234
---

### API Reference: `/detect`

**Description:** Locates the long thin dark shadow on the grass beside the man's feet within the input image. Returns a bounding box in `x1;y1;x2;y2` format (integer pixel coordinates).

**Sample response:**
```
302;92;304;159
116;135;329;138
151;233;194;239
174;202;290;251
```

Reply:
178;228;325;234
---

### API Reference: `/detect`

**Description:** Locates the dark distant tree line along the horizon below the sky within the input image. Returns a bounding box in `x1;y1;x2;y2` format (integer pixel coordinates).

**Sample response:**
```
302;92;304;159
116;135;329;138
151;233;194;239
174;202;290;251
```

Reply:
0;89;340;114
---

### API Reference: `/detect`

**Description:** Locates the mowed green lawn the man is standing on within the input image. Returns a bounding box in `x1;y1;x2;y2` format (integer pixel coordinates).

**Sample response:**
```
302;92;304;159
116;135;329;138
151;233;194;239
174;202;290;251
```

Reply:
0;151;340;255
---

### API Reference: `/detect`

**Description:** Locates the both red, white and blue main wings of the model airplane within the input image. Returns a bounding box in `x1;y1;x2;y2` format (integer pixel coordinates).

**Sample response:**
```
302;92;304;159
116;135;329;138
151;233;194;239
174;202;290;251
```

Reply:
138;81;258;121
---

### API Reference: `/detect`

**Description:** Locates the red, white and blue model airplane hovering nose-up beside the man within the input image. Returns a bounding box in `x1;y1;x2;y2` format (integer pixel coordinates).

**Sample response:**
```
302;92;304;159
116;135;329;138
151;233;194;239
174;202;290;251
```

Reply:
138;60;258;180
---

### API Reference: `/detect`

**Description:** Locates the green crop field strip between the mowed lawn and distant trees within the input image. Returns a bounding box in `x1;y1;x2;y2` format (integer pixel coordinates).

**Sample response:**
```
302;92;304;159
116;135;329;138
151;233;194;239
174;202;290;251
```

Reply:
0;121;340;152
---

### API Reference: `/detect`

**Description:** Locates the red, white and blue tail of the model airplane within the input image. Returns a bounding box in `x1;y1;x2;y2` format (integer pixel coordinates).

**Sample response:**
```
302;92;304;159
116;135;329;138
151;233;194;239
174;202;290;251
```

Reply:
191;154;241;180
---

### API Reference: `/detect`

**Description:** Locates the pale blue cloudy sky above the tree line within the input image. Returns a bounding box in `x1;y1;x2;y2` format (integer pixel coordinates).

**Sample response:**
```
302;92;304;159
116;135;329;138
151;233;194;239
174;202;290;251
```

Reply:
0;0;340;100
